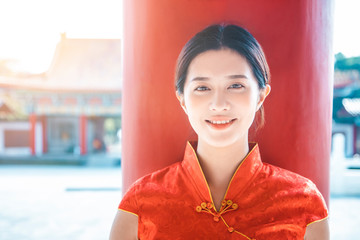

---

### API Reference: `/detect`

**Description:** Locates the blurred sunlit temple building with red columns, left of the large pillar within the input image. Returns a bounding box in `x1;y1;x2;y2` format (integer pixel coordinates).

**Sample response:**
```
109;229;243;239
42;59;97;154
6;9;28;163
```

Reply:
0;34;122;163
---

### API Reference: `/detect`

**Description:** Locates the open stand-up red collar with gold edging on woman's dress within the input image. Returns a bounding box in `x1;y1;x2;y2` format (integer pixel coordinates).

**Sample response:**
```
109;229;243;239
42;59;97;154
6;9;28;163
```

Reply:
182;142;262;202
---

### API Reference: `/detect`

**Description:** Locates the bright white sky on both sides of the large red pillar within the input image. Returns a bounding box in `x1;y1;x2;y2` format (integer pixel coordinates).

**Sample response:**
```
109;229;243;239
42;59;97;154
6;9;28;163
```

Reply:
0;0;360;73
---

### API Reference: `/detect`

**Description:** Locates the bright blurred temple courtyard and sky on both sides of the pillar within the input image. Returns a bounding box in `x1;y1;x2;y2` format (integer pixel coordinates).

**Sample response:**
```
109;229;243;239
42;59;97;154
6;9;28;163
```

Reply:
0;0;360;240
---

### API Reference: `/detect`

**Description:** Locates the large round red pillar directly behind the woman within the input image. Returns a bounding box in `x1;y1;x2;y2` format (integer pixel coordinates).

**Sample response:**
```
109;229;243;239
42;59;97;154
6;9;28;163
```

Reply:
122;0;333;202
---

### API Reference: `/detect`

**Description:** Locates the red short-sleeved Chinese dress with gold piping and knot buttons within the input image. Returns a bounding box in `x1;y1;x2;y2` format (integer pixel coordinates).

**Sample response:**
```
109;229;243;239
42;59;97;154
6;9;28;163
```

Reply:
119;143;328;240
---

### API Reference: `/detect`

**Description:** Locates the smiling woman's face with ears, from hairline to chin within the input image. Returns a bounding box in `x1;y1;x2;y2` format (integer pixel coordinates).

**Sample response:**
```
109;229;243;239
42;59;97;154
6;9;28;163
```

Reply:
178;48;270;147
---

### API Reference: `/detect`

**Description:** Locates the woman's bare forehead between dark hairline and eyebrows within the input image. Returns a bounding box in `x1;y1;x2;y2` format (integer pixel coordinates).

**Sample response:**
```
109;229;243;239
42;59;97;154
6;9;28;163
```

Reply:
187;48;252;78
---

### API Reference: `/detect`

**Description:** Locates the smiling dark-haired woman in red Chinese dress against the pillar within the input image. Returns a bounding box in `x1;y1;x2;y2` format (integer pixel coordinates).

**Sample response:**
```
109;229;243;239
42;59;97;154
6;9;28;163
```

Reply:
110;25;329;240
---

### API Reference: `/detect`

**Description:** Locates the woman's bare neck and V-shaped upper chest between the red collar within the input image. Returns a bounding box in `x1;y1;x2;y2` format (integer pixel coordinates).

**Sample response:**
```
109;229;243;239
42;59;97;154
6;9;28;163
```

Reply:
197;139;249;209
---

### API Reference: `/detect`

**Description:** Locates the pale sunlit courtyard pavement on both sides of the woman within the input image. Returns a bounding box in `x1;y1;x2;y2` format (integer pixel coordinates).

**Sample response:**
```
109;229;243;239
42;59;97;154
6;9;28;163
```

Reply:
0;165;360;240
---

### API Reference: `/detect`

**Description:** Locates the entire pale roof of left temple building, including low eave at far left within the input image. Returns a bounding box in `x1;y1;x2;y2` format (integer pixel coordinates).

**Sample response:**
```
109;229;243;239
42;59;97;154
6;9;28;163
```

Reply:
0;36;122;92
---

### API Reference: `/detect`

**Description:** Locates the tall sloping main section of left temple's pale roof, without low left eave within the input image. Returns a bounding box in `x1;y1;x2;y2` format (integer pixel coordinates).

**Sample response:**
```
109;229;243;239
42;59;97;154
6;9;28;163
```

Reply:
44;37;122;90
